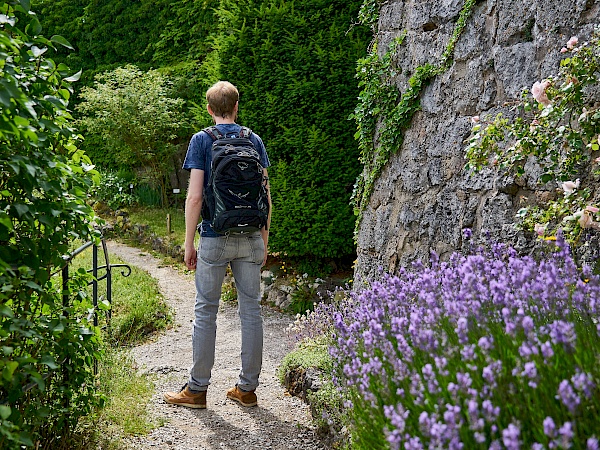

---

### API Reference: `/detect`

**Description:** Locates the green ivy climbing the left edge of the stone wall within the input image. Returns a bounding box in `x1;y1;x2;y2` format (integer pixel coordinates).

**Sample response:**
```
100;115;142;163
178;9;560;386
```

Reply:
350;0;476;237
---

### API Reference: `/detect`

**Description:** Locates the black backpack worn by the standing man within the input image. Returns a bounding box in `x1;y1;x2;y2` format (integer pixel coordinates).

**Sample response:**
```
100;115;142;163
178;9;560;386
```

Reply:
202;126;269;234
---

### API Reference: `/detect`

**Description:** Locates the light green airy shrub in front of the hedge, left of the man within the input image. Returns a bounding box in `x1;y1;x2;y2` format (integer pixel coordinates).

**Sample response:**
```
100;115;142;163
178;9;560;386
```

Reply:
77;65;187;206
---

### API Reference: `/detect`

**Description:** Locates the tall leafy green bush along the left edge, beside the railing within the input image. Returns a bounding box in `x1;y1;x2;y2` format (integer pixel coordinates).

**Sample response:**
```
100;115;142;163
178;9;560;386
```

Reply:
0;0;102;448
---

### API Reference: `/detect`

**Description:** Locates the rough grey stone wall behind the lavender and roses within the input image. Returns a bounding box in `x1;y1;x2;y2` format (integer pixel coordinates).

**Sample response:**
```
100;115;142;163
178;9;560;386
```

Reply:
356;0;600;278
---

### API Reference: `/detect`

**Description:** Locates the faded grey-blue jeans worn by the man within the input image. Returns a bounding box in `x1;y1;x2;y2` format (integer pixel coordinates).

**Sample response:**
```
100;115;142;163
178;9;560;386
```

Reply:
188;232;265;391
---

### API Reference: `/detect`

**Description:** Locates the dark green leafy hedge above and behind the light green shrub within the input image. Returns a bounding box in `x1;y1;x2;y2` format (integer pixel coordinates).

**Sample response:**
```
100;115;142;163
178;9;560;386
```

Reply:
32;0;218;119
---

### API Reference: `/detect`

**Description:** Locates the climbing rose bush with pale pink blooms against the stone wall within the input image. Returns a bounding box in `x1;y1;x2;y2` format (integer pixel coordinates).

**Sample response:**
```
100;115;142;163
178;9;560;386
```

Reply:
466;29;600;242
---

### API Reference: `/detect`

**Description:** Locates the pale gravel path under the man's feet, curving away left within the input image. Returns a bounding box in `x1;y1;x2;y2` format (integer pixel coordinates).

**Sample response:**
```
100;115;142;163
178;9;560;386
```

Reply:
108;242;328;450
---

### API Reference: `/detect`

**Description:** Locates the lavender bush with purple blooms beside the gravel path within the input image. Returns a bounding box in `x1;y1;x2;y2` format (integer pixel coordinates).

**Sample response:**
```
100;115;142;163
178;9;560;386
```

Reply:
328;238;600;449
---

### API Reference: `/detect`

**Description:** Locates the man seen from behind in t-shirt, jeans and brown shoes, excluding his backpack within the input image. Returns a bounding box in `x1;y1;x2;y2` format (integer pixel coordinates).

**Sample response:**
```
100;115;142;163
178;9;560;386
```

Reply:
164;81;271;408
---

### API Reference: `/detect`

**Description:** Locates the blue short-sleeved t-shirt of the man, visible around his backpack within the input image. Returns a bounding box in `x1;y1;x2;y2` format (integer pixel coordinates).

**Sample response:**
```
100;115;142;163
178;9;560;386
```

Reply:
183;123;270;237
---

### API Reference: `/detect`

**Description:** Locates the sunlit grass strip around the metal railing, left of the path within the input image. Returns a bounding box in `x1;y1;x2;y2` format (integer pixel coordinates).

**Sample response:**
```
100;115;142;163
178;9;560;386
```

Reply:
66;248;172;450
